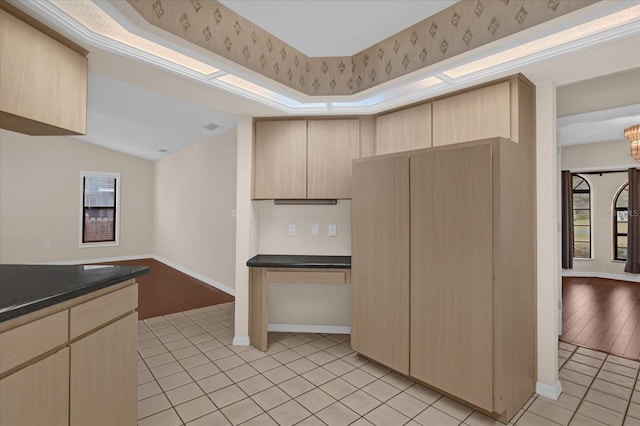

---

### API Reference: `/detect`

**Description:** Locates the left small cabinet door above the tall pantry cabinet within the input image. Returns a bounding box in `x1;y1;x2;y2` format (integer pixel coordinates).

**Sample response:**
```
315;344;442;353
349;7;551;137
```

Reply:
375;104;431;155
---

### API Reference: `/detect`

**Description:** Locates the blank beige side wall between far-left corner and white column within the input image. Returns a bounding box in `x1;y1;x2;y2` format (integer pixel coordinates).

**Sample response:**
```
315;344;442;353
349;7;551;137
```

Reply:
153;129;237;293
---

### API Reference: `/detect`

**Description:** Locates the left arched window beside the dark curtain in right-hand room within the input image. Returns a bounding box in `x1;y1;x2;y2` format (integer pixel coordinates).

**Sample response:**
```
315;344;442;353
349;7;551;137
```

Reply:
572;175;591;259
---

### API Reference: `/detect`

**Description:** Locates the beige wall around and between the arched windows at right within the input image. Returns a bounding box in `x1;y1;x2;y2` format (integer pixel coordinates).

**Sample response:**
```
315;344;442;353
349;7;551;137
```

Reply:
562;140;640;281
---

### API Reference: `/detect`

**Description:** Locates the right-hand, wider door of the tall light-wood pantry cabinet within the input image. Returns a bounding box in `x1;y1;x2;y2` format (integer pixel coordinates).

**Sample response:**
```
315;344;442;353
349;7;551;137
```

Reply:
410;144;493;411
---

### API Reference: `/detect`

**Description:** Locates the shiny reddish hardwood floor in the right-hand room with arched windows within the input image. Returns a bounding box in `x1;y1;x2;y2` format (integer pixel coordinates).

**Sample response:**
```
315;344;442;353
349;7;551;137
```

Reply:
560;277;640;360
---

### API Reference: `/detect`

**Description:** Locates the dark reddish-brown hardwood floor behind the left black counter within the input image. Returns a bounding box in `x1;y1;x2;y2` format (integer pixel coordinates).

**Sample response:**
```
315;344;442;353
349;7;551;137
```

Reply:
101;259;235;320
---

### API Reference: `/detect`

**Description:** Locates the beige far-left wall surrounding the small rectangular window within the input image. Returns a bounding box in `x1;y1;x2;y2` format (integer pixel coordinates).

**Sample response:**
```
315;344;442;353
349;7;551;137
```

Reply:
0;130;153;263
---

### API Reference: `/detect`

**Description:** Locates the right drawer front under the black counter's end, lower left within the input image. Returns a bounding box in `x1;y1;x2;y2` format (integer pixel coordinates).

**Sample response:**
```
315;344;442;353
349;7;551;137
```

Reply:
69;284;138;339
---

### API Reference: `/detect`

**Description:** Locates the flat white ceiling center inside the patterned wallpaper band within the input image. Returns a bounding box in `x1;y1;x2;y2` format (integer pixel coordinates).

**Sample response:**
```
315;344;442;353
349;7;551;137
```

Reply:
220;0;458;57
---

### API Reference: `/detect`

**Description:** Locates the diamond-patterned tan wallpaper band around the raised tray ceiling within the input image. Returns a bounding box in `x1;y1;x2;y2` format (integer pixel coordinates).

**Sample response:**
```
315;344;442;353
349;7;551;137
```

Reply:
128;0;599;96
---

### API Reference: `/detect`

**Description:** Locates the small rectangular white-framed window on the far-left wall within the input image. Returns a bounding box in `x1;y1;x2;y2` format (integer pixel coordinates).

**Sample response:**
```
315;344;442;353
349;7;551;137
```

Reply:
80;172;120;246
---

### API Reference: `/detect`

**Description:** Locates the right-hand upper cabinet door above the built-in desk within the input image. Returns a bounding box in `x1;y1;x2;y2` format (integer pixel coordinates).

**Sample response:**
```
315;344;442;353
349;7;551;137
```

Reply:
307;120;360;198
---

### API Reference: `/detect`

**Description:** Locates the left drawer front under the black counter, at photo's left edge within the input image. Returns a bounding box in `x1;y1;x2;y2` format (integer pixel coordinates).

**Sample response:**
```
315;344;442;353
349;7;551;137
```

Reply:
0;311;69;374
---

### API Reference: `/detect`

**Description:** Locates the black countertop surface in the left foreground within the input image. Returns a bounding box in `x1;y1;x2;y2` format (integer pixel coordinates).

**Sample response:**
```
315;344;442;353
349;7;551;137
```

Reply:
0;265;149;322
